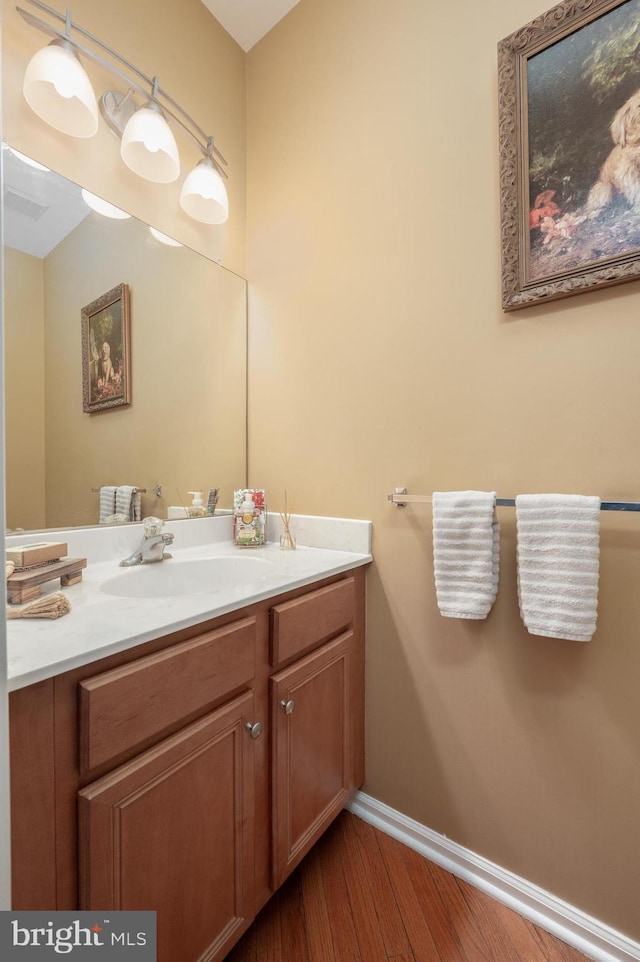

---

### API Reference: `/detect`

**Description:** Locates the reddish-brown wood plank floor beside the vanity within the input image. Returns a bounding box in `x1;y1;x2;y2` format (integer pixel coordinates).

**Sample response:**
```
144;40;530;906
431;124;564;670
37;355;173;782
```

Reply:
225;812;586;962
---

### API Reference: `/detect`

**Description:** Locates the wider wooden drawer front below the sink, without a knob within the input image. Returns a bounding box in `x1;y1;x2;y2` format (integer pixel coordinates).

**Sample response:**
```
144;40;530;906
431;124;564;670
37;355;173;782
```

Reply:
79;618;256;772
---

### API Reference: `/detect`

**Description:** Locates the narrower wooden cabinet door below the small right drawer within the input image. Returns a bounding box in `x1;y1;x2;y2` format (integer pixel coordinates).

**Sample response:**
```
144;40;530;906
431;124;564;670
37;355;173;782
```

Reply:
271;631;355;889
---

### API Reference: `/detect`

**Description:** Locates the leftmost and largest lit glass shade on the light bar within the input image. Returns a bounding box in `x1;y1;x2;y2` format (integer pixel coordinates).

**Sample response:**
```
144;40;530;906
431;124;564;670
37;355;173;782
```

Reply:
22;40;98;137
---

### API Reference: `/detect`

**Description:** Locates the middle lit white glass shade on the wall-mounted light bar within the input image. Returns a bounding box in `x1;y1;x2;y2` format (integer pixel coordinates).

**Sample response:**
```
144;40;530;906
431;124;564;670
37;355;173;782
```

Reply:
120;103;180;184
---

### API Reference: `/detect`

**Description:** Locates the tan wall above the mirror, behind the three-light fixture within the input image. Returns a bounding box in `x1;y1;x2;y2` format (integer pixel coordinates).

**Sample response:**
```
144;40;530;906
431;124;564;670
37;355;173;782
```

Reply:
2;0;246;275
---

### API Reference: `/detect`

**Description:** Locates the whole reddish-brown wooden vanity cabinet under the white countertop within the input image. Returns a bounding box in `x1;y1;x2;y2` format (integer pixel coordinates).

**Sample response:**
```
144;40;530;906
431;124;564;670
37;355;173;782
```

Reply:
10;568;365;962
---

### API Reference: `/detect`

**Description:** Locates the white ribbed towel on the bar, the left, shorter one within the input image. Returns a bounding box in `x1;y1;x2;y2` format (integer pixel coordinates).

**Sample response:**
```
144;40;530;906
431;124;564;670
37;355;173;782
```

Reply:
432;491;500;619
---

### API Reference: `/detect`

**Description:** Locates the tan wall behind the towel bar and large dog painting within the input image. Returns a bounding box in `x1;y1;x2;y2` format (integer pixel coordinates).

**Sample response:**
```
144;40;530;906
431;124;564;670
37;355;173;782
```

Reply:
248;0;640;939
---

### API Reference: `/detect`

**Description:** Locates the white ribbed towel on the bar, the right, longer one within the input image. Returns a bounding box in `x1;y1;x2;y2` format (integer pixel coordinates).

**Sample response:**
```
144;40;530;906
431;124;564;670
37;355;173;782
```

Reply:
516;494;600;641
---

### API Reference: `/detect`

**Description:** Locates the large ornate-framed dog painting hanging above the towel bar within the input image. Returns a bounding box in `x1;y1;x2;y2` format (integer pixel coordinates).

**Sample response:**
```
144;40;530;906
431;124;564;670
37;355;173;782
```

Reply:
498;0;640;311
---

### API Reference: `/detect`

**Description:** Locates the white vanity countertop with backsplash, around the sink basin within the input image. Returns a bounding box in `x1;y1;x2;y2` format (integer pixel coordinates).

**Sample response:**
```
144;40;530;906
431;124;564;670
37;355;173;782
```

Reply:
7;519;372;691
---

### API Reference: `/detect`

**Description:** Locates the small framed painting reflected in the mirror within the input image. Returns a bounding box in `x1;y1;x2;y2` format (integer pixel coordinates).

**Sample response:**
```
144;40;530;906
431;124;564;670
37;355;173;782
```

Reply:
81;284;131;414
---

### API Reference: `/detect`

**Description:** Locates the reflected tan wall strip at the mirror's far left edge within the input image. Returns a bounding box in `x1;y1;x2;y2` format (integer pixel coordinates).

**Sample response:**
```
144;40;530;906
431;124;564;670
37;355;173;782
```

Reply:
3;247;45;528
